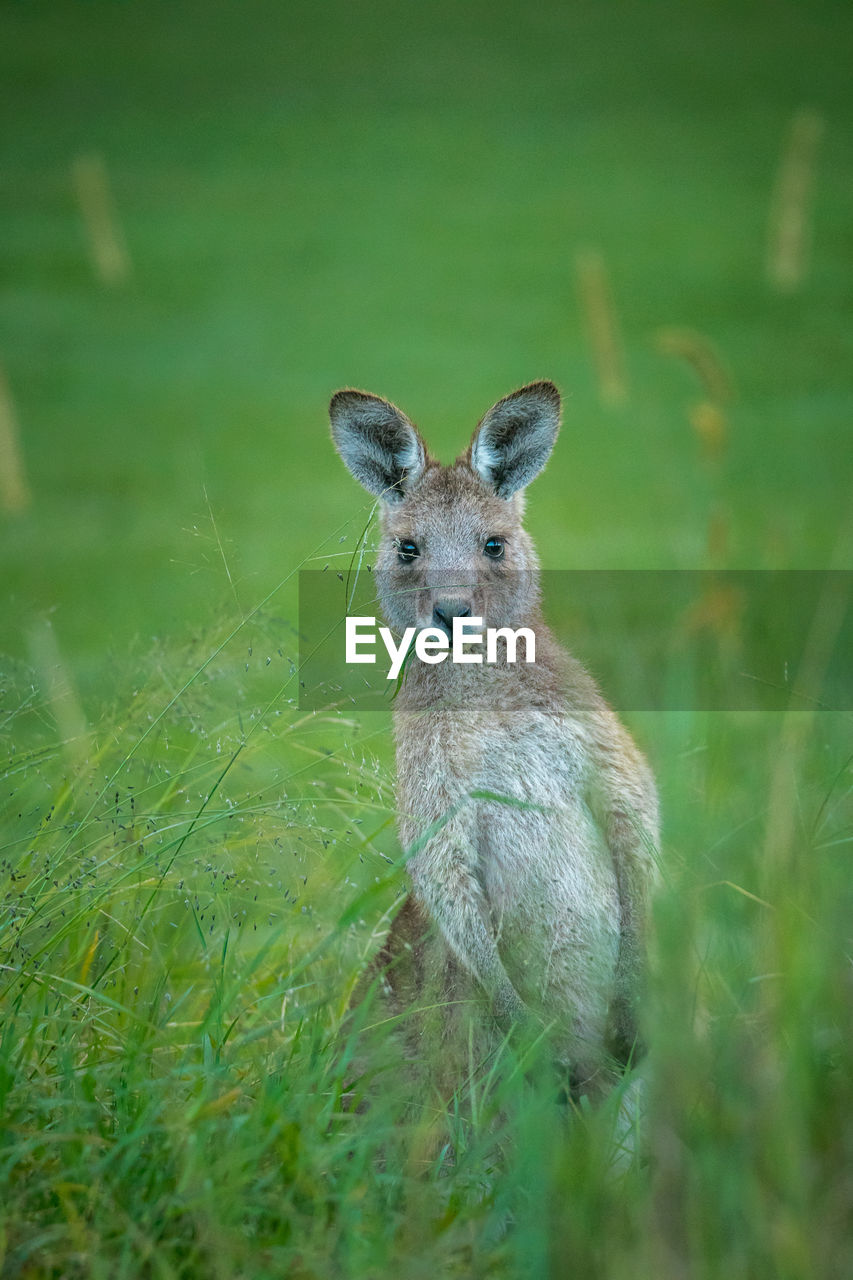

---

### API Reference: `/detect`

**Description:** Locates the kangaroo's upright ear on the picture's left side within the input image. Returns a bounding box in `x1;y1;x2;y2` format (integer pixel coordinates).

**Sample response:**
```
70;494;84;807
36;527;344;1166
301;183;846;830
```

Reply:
329;390;427;502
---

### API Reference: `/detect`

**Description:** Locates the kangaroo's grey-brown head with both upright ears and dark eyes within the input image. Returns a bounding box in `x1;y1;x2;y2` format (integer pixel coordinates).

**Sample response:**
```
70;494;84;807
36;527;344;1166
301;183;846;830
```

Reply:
329;381;560;634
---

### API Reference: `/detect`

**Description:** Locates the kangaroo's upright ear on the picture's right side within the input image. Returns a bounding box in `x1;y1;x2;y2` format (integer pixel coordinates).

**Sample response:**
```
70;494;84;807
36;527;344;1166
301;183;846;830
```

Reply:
470;383;560;498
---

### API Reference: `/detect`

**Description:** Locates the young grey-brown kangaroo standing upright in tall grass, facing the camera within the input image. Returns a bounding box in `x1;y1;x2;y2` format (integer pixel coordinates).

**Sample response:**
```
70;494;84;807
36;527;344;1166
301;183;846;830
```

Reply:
330;381;658;1096
